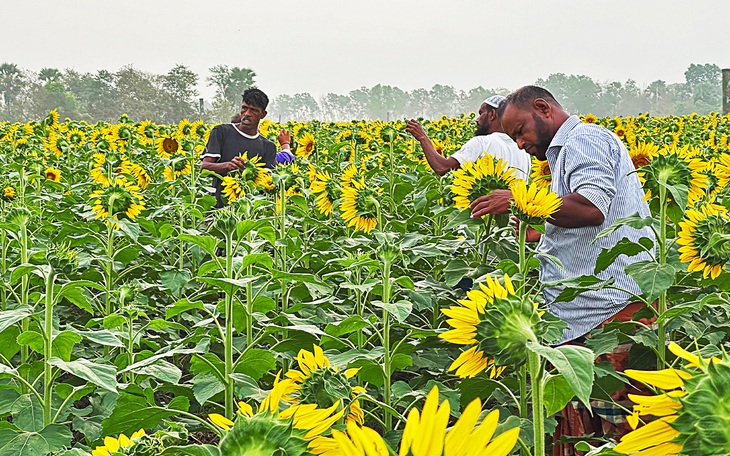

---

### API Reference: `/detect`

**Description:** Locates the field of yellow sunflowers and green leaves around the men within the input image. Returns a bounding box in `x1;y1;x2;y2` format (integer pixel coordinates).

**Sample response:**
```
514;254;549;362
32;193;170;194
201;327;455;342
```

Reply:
0;112;730;456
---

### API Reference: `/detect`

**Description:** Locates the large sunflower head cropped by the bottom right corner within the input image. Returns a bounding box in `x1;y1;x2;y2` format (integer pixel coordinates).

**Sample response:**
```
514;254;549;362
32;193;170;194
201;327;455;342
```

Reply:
613;342;730;455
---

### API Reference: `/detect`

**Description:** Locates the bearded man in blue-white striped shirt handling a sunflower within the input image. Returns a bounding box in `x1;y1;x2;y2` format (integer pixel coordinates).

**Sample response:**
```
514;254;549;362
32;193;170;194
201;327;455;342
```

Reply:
471;86;656;454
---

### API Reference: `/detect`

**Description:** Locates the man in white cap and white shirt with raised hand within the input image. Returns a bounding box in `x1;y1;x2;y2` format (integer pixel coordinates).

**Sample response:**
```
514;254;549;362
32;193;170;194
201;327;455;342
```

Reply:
406;95;531;180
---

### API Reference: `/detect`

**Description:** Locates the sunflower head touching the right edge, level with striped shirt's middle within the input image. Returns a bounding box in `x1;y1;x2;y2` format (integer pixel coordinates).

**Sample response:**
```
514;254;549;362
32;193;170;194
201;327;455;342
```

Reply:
677;204;730;279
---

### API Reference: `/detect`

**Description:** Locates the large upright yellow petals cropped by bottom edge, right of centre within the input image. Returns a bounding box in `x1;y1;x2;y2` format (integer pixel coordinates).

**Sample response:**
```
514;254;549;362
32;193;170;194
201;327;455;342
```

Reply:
398;386;520;456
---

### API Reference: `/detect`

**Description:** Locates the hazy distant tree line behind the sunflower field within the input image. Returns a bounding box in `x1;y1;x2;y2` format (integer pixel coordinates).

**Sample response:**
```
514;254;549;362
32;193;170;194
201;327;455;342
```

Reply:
0;63;722;123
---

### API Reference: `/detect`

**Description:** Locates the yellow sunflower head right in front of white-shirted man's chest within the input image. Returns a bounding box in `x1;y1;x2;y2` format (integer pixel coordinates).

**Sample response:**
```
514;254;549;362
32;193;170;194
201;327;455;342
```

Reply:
451;154;516;210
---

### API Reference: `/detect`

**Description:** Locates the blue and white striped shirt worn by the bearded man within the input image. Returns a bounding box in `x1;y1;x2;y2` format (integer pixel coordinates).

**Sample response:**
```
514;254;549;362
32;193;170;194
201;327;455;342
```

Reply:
538;116;656;343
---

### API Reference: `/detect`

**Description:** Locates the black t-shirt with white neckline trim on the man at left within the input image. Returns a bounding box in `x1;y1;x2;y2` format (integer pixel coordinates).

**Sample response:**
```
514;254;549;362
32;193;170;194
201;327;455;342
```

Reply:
201;124;276;207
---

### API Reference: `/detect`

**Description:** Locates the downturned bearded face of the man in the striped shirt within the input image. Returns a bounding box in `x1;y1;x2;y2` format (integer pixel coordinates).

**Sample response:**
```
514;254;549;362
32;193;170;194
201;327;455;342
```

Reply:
502;104;554;160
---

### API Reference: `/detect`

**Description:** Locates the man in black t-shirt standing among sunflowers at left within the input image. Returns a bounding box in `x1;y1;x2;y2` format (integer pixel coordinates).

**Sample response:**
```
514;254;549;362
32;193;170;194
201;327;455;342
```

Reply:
200;87;276;207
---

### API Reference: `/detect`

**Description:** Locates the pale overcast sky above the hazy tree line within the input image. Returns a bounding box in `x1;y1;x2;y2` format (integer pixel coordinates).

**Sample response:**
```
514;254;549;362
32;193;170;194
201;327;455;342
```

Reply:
0;0;730;99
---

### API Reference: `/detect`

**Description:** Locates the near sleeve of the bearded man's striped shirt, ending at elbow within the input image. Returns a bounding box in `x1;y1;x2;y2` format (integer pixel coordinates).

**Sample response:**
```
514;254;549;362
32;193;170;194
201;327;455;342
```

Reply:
564;134;618;217
